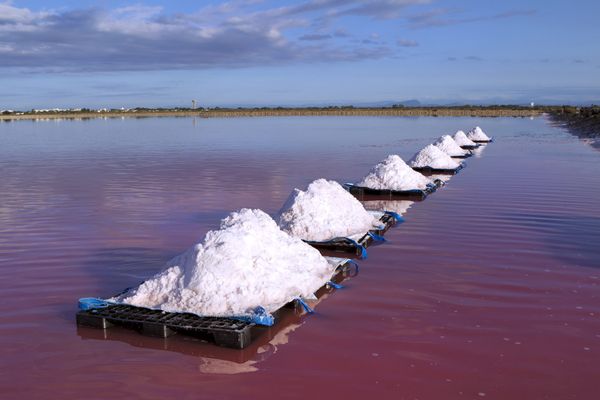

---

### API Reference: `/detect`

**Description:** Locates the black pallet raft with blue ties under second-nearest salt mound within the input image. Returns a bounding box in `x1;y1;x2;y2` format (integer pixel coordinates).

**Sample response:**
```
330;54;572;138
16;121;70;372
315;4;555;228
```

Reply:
304;212;403;259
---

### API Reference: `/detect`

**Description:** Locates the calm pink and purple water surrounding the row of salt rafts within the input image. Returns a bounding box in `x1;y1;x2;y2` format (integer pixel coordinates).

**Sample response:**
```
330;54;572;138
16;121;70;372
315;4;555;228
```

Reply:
0;117;600;399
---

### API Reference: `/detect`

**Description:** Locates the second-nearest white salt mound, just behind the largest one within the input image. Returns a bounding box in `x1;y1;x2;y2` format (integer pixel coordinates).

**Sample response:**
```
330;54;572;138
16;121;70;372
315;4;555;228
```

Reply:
279;179;380;241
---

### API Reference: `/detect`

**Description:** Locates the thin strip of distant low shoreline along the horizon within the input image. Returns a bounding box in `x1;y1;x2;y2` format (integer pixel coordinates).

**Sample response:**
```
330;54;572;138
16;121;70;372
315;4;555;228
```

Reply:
0;107;547;121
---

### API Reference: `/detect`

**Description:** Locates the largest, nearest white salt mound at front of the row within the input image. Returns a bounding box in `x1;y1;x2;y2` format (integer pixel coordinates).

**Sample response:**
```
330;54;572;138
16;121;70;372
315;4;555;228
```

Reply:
109;209;334;316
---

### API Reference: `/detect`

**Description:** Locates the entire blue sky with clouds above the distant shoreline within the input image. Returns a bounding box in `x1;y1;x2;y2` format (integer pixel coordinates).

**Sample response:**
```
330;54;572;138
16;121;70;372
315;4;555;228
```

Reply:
0;0;600;110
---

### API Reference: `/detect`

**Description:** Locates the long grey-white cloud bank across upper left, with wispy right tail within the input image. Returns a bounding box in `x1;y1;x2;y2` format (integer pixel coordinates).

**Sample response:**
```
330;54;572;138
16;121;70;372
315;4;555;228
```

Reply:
0;0;529;72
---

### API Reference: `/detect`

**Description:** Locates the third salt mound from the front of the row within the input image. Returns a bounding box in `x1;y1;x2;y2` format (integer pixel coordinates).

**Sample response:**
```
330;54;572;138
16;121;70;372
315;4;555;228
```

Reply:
356;155;433;190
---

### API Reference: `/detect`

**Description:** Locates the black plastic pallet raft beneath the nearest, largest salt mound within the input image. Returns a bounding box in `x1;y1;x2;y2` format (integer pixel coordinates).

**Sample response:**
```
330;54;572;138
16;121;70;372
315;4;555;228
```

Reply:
76;260;358;349
